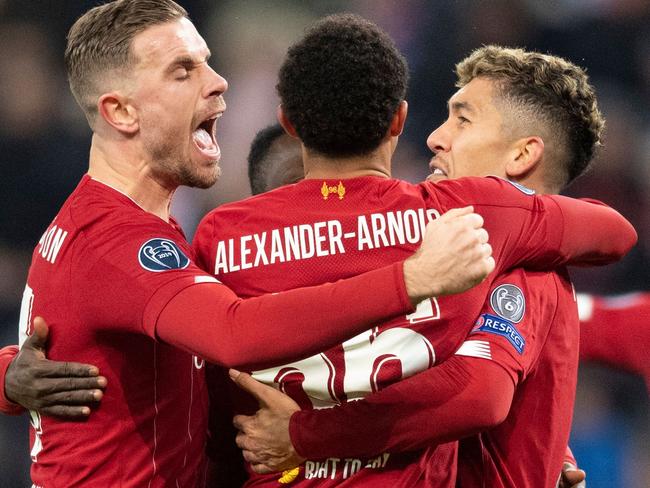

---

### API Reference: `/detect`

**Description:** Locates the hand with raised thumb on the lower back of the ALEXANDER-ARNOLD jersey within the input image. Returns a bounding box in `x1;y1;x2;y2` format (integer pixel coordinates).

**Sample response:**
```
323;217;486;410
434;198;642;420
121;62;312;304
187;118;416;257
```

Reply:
229;369;305;474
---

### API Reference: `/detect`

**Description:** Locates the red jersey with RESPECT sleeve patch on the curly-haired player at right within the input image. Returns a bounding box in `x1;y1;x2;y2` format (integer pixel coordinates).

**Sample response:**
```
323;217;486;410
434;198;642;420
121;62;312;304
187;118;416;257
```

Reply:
456;270;580;488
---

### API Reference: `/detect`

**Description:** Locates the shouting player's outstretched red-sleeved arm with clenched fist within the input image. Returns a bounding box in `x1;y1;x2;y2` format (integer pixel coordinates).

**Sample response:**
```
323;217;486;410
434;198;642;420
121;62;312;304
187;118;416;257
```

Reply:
152;209;494;367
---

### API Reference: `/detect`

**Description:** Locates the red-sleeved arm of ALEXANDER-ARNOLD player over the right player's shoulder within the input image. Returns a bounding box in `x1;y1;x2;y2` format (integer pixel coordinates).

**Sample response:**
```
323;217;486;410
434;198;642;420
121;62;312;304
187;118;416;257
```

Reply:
424;177;637;272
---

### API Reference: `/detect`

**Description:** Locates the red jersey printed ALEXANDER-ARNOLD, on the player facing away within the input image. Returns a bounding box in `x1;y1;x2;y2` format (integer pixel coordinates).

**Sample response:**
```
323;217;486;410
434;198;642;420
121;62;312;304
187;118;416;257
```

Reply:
194;177;619;486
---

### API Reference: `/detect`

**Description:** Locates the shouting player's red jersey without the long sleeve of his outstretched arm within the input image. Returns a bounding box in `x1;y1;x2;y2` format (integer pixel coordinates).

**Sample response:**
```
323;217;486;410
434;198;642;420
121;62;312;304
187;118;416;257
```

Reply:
20;176;208;488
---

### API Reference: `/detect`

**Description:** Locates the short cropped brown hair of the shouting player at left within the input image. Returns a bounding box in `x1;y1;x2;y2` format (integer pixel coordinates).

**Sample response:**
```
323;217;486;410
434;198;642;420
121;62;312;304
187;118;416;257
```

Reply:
65;0;187;127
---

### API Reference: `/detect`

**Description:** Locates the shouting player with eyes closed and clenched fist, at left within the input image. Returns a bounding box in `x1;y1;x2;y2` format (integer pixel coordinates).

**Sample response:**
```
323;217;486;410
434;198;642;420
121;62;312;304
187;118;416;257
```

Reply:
0;0;502;487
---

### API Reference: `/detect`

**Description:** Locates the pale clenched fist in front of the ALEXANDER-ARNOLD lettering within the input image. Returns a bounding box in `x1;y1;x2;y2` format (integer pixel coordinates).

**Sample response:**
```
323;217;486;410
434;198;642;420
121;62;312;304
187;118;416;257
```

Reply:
404;207;495;303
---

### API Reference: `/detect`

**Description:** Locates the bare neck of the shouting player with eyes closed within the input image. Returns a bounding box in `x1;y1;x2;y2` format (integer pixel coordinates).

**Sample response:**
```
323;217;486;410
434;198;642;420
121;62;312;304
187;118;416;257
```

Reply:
88;134;176;222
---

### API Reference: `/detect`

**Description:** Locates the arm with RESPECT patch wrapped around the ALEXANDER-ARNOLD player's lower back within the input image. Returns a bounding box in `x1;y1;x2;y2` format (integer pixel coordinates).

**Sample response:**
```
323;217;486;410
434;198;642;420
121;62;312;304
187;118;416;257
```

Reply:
230;270;540;471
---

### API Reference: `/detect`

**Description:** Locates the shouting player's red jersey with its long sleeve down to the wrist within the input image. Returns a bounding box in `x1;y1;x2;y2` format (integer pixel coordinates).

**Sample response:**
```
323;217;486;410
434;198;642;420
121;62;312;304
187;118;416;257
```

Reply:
19;176;413;488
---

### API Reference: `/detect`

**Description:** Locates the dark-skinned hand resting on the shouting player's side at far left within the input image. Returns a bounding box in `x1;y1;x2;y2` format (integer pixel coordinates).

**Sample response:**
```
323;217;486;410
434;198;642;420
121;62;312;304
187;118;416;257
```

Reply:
4;317;106;418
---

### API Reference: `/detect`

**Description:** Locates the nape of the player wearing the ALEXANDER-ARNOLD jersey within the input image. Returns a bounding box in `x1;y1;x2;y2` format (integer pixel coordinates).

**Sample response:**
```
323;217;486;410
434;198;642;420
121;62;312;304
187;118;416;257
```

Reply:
302;143;393;179
